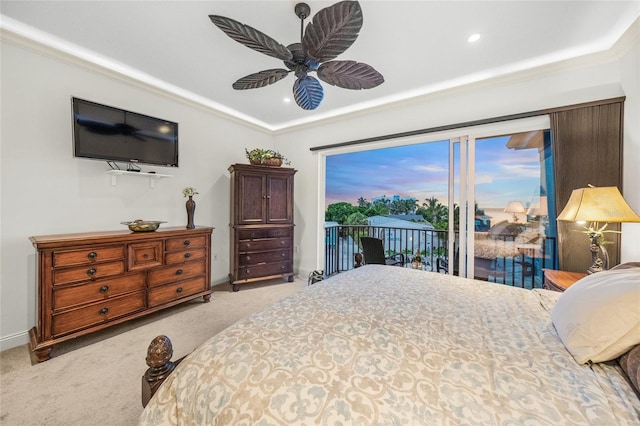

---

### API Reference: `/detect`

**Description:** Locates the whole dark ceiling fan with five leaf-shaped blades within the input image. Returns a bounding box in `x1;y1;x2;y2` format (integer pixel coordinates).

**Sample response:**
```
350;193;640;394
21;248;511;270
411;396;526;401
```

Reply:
209;1;384;110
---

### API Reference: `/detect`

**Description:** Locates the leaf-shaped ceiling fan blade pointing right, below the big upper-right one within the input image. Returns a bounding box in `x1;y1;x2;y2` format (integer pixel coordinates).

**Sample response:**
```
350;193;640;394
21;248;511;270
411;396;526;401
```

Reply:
318;61;384;90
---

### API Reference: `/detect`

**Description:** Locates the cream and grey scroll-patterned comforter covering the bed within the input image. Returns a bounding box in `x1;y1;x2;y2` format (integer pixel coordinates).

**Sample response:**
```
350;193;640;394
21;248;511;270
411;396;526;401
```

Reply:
140;265;640;425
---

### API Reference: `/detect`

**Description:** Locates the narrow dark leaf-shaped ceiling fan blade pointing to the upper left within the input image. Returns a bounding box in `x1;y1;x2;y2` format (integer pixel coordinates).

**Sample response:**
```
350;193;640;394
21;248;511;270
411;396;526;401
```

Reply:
209;15;292;61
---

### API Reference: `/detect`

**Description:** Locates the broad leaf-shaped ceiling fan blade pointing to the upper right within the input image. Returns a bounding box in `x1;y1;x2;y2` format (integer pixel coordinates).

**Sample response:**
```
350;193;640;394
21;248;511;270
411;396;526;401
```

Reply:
302;1;362;62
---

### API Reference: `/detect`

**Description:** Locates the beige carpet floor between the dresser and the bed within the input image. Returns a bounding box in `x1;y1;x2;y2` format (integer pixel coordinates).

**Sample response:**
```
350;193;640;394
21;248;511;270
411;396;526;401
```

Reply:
0;279;306;426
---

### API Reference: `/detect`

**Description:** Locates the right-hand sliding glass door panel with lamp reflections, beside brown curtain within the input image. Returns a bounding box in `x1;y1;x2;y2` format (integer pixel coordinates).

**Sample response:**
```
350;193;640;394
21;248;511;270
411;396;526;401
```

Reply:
449;125;557;288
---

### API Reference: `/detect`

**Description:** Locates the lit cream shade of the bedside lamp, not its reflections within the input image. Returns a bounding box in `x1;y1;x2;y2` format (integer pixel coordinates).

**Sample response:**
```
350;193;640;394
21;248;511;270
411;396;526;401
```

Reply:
558;186;640;222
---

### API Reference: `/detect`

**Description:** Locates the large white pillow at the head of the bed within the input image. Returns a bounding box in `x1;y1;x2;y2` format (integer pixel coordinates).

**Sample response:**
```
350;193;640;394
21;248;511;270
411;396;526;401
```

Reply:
551;268;640;364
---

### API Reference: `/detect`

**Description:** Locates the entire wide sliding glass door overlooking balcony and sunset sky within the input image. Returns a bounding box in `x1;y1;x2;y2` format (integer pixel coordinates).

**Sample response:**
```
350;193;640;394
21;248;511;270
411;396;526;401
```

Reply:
320;117;557;288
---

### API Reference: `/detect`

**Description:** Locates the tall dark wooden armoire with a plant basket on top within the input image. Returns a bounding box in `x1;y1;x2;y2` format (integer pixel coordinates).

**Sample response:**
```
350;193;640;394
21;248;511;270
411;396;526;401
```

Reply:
229;164;296;291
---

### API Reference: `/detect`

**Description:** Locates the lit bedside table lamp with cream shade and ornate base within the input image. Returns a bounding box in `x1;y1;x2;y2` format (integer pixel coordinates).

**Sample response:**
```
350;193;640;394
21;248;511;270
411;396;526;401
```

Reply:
558;185;640;274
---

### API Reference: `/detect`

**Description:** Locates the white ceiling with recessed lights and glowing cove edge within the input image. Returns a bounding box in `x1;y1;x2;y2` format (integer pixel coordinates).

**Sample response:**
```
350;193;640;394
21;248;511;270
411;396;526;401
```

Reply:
0;0;640;130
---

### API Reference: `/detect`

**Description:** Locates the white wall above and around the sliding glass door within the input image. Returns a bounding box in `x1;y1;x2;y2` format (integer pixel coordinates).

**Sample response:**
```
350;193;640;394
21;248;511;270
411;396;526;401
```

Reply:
276;38;640;273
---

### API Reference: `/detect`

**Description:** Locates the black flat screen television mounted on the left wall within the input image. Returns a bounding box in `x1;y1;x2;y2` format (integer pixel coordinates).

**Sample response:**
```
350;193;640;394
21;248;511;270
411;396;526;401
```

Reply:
72;98;178;167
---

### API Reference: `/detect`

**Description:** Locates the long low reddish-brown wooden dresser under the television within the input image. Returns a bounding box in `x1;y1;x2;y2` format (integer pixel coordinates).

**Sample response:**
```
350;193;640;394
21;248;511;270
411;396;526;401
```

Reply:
29;227;213;362
